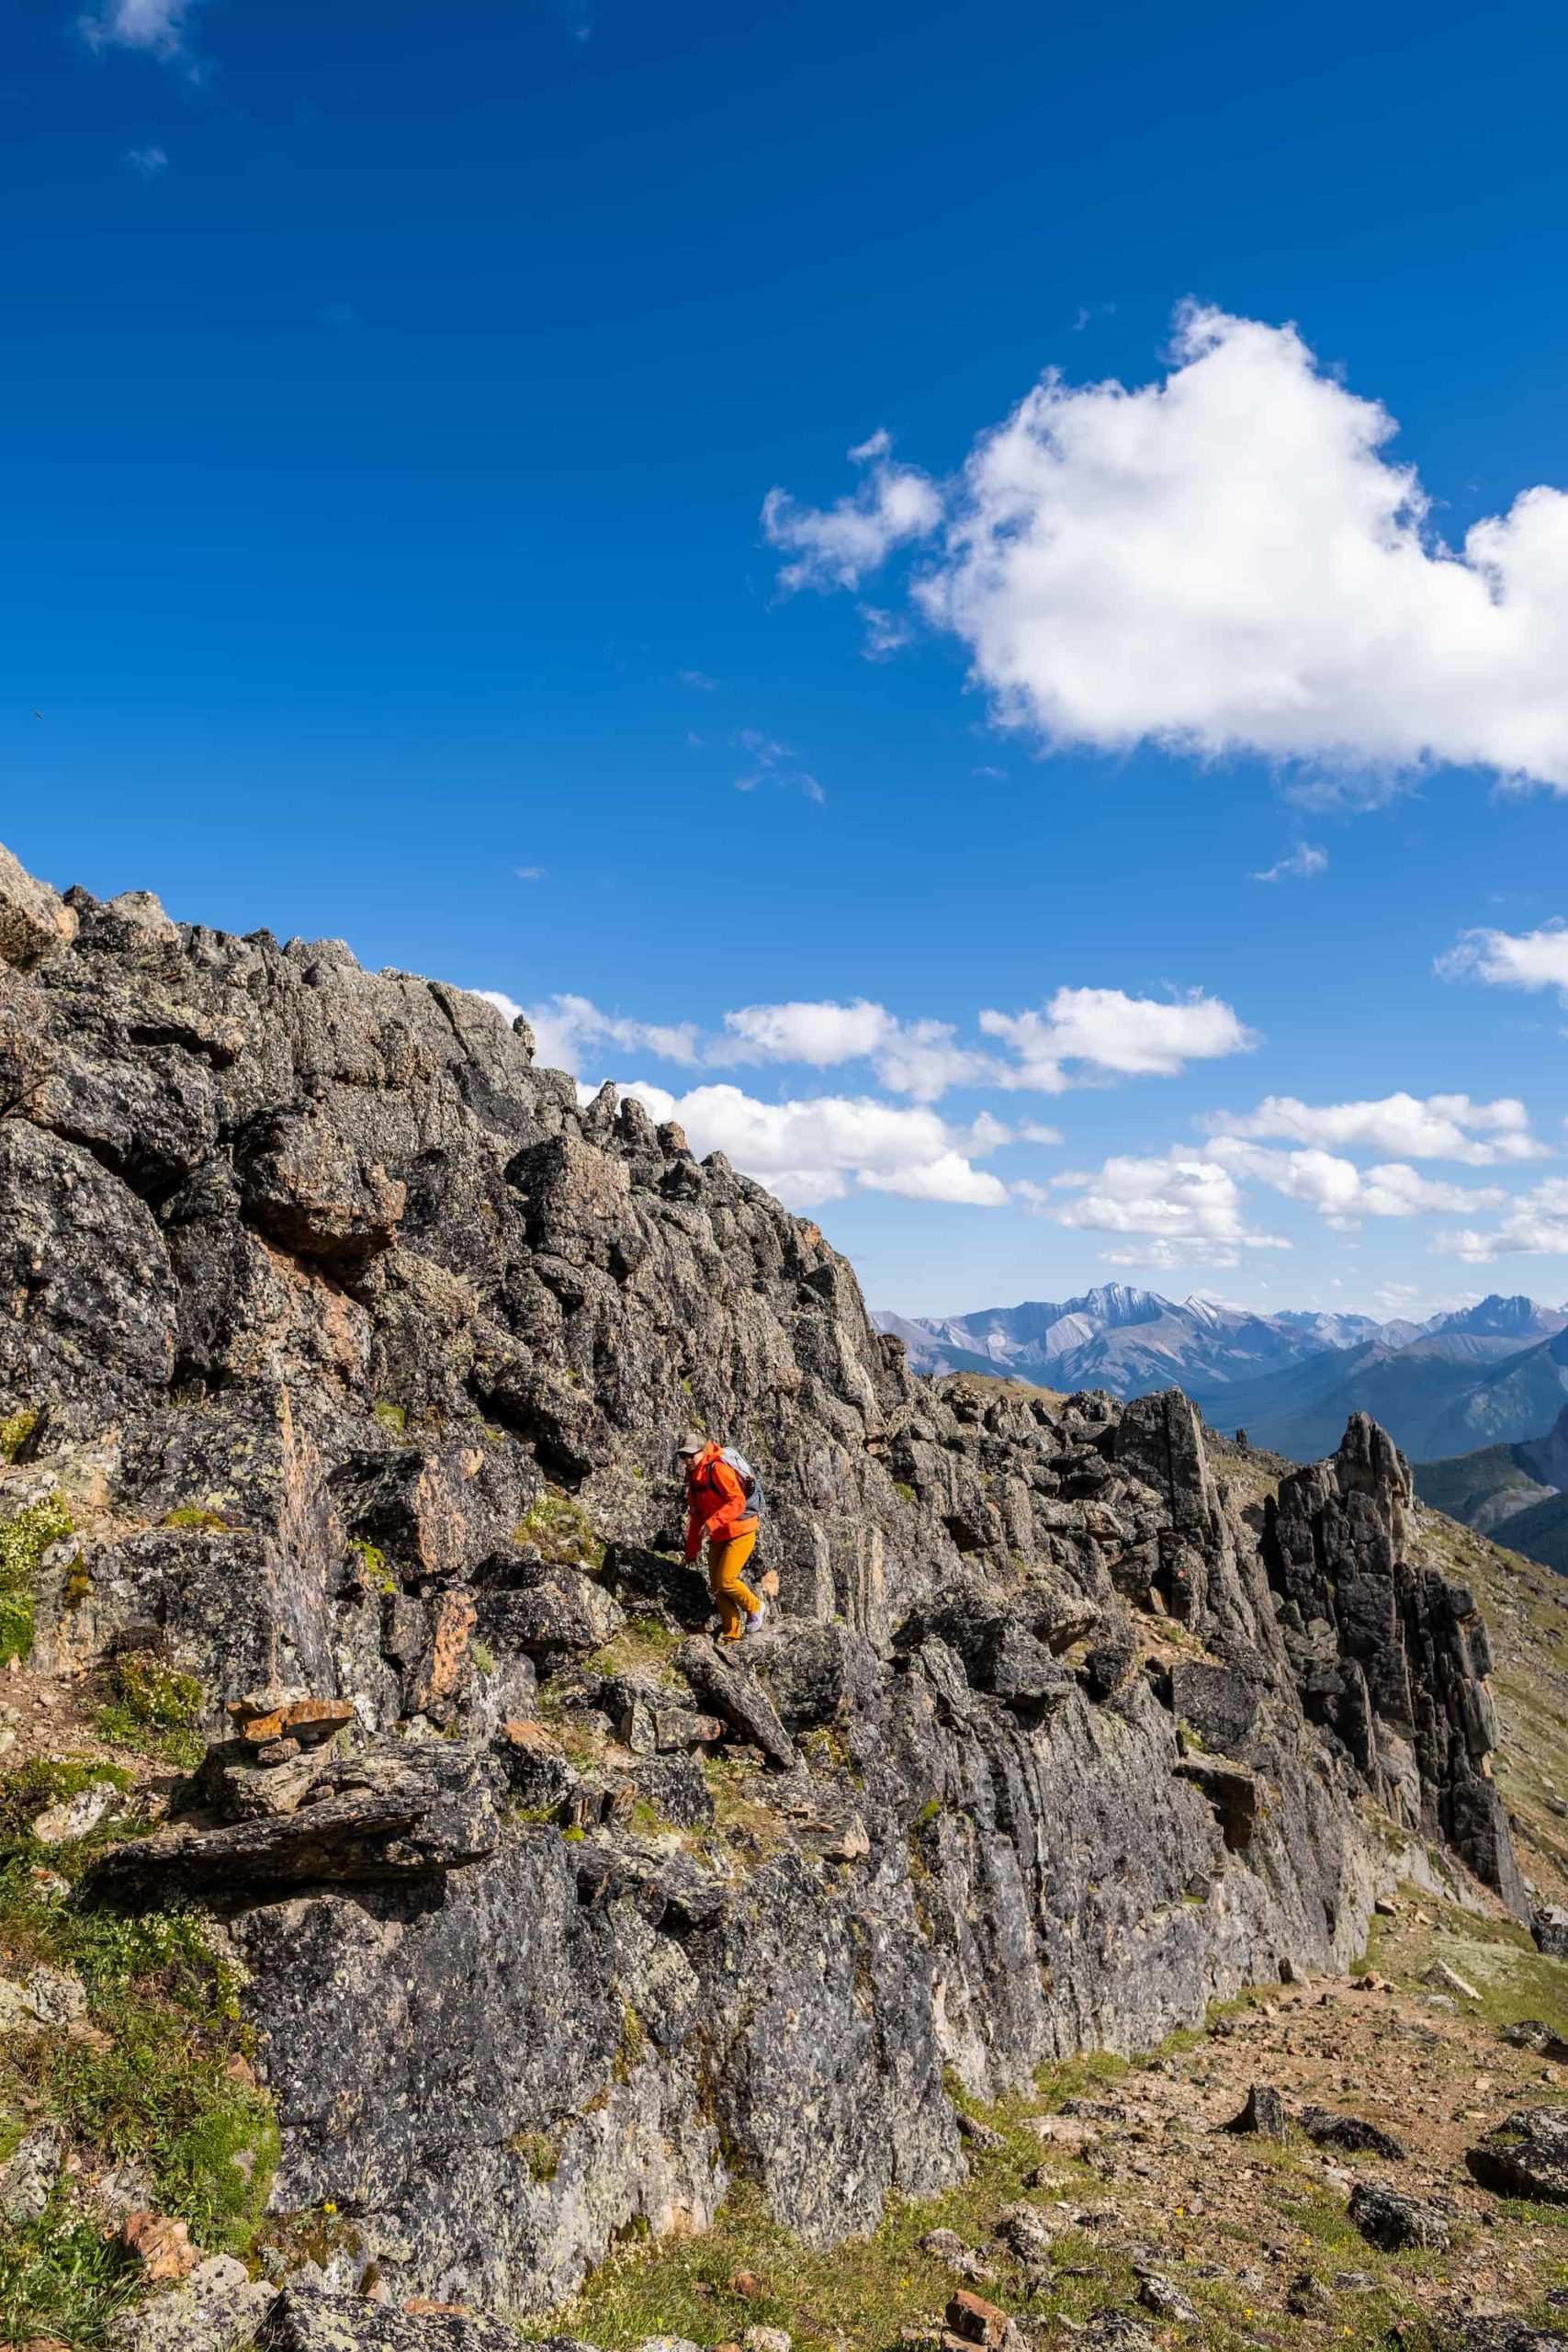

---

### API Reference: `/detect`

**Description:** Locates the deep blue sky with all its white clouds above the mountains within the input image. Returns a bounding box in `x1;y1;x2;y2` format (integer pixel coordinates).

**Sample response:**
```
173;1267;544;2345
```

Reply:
0;0;1568;1312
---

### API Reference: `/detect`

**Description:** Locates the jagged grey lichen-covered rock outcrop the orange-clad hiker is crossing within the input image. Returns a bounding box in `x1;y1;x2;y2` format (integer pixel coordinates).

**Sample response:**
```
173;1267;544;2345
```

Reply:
0;837;1547;2352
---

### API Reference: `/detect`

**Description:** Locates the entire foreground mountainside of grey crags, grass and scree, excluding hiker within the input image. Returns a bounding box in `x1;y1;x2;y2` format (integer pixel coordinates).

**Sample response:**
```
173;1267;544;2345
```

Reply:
0;856;1568;2352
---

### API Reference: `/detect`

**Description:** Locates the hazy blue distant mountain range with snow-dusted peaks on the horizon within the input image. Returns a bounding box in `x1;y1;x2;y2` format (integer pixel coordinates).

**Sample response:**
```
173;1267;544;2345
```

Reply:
874;1282;1568;1475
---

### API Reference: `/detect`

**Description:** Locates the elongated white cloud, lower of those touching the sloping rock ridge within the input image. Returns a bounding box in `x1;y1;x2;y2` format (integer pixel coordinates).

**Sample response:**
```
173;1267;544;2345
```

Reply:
606;1080;1009;1209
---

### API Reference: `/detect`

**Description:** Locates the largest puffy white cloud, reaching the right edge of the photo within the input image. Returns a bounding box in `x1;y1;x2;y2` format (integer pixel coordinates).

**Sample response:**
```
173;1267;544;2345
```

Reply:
780;306;1568;790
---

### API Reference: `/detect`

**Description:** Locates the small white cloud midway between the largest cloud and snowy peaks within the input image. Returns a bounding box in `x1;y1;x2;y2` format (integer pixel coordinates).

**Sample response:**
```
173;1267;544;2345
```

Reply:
980;988;1260;1093
